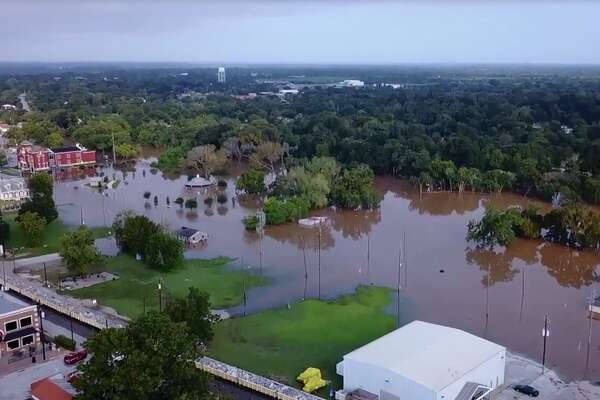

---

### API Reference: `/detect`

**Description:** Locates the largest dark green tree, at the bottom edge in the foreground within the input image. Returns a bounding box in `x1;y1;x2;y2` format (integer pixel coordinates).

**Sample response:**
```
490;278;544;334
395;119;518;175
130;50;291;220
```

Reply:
74;311;209;400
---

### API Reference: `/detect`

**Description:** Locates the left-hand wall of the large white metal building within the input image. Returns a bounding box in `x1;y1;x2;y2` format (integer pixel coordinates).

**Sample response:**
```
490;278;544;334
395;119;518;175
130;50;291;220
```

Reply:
343;360;436;400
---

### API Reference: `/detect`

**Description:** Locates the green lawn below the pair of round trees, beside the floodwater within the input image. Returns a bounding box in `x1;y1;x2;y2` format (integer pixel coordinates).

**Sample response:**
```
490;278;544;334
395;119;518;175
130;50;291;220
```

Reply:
65;255;267;317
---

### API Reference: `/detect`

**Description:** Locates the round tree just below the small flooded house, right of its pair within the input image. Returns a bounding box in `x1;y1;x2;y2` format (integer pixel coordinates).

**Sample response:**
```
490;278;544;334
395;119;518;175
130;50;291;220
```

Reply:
144;232;183;271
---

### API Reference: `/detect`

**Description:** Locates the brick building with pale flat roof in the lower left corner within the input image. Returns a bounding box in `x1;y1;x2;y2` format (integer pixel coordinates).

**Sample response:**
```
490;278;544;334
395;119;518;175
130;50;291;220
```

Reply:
0;292;40;358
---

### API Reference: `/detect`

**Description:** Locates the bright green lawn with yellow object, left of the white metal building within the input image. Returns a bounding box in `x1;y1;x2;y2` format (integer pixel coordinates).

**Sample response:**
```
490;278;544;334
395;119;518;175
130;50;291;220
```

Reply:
209;287;395;394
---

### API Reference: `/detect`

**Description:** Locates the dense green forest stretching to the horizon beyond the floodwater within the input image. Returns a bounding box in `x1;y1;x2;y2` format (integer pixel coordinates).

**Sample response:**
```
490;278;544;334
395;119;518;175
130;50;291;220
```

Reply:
0;66;600;204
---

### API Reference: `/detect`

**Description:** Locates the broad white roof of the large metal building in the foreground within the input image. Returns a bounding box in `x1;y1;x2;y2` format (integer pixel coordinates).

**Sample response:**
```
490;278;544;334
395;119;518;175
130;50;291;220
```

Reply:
344;321;506;392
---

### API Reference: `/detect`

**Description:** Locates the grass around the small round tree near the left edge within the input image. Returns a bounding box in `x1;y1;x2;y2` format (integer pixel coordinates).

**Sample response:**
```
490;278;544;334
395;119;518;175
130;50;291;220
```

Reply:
4;214;110;257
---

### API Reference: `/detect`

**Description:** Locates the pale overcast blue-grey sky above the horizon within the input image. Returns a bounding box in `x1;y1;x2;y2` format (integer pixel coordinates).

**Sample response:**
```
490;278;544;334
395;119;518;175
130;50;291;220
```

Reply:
0;0;600;65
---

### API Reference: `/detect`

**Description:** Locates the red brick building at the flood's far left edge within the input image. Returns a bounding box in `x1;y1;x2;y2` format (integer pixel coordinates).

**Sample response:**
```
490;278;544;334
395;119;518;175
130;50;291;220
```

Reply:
17;141;96;173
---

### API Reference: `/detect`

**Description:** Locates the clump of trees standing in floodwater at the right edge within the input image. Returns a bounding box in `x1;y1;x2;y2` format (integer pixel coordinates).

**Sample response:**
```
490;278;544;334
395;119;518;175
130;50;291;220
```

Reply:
467;203;600;250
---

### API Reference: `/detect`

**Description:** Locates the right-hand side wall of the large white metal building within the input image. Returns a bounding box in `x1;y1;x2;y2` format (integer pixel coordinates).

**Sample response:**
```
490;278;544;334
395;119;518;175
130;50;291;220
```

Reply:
438;351;506;400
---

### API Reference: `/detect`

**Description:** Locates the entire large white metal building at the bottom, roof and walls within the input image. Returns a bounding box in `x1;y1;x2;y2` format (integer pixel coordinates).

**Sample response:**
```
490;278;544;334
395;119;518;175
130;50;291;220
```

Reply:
336;321;506;400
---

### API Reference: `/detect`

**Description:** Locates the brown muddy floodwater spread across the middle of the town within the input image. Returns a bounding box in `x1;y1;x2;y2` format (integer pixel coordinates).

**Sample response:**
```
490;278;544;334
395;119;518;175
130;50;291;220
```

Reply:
55;160;600;380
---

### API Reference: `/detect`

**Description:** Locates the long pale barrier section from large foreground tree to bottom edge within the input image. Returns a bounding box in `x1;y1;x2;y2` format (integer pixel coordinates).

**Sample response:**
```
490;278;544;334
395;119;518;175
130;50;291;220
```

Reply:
196;357;323;400
